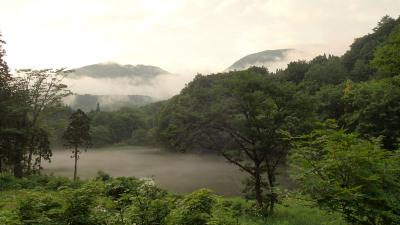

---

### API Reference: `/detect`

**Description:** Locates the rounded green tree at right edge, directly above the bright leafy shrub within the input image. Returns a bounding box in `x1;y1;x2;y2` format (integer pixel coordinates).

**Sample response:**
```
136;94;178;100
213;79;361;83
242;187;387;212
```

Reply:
343;76;400;150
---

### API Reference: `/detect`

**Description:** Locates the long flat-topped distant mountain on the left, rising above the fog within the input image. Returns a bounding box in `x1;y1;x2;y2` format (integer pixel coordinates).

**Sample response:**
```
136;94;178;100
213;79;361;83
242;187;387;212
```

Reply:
70;63;169;80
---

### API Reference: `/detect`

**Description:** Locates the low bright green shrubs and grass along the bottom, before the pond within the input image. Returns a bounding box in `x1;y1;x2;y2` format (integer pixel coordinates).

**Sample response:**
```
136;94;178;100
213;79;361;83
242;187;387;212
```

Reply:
0;173;344;225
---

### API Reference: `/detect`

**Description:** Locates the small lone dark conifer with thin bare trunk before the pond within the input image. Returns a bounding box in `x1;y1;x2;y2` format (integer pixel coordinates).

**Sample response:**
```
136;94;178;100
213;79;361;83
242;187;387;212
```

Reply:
64;109;91;180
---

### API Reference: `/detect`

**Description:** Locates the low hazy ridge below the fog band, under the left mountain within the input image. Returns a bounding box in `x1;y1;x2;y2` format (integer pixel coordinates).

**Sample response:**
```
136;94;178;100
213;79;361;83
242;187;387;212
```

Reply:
64;94;156;112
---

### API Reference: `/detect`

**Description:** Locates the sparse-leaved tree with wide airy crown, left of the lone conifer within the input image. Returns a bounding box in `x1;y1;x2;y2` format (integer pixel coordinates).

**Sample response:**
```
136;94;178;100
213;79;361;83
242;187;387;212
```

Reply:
13;69;71;174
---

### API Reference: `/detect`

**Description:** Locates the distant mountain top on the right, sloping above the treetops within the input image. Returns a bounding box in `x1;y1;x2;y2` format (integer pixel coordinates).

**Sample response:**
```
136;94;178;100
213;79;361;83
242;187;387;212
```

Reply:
226;49;295;71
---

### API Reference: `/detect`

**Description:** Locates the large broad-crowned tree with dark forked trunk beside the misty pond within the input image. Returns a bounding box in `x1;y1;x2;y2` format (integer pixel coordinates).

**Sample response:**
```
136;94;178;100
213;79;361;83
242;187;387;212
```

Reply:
156;71;311;213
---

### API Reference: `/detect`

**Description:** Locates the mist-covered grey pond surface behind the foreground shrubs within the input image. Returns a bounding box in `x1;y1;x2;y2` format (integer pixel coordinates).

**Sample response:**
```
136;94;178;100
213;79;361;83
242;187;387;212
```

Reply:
43;147;246;195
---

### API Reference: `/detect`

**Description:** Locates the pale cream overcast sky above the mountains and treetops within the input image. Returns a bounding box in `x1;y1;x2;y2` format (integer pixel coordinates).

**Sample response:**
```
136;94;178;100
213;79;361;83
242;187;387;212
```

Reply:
0;0;400;73
